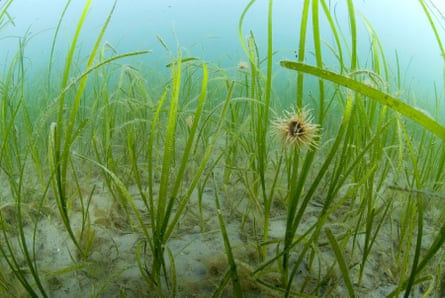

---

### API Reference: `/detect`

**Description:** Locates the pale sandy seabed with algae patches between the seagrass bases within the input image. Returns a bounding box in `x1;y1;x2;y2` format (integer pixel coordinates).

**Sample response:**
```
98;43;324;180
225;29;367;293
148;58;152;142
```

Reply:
0;162;443;297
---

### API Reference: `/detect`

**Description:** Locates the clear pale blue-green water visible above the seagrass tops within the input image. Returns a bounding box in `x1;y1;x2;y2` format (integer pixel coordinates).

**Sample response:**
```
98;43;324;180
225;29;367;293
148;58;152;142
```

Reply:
0;0;445;115
